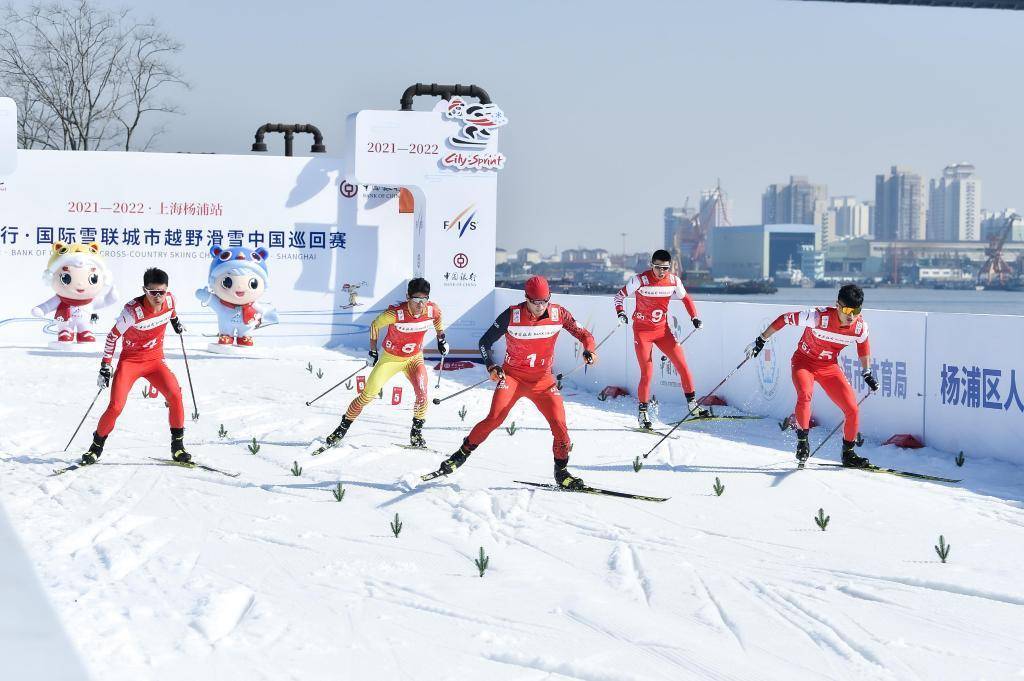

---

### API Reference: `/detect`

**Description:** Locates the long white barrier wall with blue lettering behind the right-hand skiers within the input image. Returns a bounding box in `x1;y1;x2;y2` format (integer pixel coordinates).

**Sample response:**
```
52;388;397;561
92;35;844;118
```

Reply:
495;289;1024;463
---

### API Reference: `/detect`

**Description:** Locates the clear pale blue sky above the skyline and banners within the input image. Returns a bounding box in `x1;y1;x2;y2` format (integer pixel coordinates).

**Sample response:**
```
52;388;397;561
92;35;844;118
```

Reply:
97;0;1024;252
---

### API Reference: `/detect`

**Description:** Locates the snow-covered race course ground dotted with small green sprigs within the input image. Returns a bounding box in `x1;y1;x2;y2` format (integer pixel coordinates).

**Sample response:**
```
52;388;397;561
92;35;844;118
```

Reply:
0;331;1024;681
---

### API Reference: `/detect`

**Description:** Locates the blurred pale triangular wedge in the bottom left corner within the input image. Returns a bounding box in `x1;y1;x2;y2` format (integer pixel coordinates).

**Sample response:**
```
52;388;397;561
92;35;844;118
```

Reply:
0;506;87;681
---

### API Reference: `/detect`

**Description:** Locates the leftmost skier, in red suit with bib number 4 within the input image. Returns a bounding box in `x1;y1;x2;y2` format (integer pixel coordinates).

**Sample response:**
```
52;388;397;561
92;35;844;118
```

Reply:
82;267;191;465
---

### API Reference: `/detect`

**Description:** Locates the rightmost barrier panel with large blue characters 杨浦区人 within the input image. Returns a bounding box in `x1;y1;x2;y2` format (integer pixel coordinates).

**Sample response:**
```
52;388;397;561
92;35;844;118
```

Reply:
925;313;1024;463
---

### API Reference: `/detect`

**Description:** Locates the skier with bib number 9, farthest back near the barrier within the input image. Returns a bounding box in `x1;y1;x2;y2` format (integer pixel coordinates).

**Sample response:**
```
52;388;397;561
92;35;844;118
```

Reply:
615;249;711;430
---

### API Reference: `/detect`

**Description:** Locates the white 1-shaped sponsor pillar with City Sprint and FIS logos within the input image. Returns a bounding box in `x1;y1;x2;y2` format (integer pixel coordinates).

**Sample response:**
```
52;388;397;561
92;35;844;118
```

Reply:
345;97;505;353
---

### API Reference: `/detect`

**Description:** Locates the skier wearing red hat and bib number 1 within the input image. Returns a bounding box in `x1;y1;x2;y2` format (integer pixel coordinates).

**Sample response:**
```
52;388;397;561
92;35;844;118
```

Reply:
440;276;597;490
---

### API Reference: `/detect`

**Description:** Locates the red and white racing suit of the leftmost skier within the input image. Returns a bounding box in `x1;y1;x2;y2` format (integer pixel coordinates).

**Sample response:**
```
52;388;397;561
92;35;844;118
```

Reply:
96;293;185;436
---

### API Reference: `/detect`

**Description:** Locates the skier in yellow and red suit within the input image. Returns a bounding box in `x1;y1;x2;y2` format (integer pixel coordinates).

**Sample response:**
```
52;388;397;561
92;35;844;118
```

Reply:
327;276;449;448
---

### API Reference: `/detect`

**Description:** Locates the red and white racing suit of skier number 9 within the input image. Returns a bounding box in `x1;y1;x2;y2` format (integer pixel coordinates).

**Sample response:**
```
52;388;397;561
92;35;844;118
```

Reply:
615;269;697;402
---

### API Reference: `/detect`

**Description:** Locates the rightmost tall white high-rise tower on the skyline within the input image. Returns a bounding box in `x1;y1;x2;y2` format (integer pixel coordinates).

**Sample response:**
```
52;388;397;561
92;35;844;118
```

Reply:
927;163;981;242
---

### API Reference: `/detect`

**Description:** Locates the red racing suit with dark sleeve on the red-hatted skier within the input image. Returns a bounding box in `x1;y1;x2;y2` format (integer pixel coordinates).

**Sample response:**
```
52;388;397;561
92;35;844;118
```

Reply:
466;302;594;461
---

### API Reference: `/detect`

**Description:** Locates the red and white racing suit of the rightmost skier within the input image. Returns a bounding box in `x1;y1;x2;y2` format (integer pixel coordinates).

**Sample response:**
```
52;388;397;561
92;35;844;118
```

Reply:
771;307;871;441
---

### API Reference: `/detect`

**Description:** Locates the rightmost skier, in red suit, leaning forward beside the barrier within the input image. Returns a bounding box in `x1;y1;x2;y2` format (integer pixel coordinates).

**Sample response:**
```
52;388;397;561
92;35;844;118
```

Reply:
749;284;879;468
